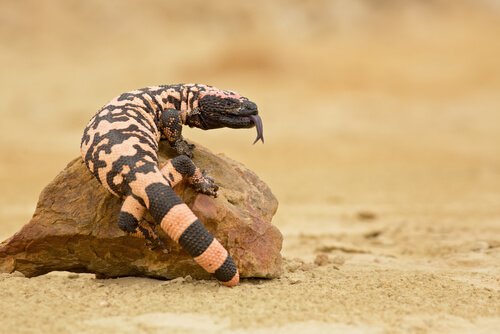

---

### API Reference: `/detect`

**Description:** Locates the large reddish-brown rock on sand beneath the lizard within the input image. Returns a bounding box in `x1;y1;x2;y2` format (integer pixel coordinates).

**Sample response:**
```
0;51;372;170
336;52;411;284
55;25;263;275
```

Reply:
0;144;282;279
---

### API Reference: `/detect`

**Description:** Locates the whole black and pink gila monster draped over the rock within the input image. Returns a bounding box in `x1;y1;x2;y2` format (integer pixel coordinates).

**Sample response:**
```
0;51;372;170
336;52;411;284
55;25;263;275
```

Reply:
81;84;264;286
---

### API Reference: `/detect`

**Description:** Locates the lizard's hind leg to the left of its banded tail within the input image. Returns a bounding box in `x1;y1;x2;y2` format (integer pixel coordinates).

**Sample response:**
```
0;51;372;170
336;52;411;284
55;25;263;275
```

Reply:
118;196;165;249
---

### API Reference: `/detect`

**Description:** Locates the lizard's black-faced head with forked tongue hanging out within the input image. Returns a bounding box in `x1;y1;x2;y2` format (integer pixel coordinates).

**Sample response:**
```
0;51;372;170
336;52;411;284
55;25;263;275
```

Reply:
186;88;264;144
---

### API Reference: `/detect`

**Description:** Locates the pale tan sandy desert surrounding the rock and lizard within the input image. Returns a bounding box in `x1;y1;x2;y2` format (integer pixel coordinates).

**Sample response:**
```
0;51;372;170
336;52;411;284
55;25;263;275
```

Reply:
0;0;500;333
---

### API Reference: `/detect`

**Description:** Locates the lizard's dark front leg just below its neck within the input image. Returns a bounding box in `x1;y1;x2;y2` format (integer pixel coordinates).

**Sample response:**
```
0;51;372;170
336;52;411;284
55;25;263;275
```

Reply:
160;109;194;158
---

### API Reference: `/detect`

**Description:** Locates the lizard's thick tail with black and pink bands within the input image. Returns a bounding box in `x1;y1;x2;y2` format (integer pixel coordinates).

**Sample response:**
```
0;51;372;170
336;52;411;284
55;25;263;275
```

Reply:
145;182;239;286
